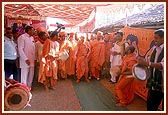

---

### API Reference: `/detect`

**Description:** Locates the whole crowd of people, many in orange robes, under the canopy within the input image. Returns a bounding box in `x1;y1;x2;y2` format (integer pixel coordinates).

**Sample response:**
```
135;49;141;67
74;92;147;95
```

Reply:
4;19;164;110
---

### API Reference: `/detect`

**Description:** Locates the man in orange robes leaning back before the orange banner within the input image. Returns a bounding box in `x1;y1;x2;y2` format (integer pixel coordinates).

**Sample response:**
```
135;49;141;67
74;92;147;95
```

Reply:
111;45;137;106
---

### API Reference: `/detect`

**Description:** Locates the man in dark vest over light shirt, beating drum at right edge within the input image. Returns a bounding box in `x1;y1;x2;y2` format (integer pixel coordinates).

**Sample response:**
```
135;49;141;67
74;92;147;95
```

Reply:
137;29;164;111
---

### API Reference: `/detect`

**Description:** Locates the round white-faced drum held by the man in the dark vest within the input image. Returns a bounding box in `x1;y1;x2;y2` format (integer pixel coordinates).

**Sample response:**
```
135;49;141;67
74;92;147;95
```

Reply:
132;64;149;81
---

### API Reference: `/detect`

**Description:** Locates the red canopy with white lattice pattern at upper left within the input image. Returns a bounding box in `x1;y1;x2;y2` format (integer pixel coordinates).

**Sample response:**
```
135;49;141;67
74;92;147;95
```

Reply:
4;3;108;26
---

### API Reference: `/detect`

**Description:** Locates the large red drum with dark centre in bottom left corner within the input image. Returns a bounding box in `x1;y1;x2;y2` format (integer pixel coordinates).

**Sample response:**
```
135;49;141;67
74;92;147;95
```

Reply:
4;83;31;111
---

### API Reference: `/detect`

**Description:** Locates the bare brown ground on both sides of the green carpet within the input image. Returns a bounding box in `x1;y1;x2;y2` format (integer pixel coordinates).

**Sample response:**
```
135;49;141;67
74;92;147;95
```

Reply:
19;78;146;112
